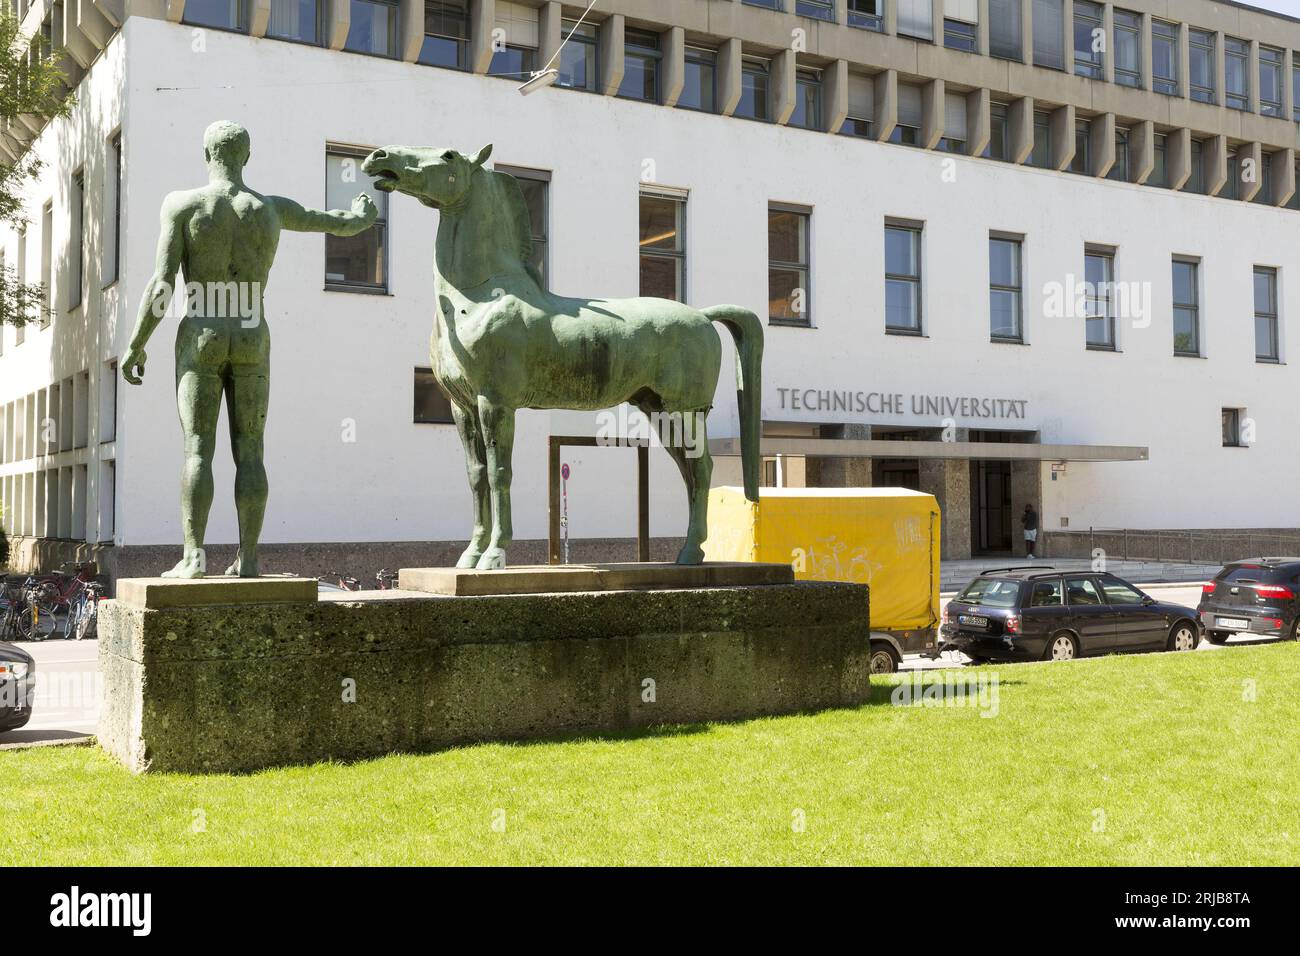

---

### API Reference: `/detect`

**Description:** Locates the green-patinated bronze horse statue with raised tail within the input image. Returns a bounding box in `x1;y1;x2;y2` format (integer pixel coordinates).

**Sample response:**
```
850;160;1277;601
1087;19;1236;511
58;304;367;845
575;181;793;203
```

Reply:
361;146;763;570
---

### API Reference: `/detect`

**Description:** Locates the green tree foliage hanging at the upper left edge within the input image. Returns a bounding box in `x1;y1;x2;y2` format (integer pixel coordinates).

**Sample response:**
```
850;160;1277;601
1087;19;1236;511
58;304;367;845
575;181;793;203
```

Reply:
0;10;72;325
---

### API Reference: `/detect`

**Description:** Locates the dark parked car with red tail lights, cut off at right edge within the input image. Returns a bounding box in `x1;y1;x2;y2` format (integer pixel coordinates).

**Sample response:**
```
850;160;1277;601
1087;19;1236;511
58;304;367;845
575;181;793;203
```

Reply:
1196;558;1300;644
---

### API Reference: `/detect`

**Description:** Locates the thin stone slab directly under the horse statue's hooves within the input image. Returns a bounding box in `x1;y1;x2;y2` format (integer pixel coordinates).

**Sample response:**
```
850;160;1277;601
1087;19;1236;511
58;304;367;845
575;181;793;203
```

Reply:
398;561;794;597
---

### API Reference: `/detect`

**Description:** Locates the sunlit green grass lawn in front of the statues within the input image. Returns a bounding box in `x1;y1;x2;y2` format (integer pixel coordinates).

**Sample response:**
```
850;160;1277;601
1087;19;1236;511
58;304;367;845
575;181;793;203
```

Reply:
0;643;1300;865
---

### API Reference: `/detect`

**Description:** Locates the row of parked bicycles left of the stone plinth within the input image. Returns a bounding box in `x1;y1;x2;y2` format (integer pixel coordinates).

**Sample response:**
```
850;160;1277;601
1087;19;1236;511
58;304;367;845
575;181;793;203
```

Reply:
0;562;104;641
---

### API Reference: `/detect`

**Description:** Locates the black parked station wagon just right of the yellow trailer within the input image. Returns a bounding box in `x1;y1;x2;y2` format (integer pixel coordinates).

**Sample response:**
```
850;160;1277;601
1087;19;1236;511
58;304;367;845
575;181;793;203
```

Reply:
941;566;1201;662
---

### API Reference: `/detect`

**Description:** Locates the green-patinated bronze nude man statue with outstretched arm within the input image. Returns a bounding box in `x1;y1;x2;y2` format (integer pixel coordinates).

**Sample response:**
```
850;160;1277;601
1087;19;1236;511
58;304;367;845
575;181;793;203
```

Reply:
122;121;378;578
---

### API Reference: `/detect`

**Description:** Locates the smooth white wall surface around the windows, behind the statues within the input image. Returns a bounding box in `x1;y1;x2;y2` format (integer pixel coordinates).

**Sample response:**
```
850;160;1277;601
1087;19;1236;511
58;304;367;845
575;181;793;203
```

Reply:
0;18;1300;544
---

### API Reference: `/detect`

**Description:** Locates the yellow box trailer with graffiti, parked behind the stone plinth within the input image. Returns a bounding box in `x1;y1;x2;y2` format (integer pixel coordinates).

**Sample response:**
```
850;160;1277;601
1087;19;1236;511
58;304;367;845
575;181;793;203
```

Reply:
705;488;940;672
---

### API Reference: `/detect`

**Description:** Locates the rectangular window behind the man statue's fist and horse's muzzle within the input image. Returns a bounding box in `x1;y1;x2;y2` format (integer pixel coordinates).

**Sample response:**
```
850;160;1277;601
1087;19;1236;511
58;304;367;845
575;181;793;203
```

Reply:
325;147;389;293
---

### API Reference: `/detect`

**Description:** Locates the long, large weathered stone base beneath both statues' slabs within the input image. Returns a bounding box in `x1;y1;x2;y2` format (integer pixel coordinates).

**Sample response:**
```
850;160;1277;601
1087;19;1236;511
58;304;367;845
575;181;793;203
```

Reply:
99;583;871;773
